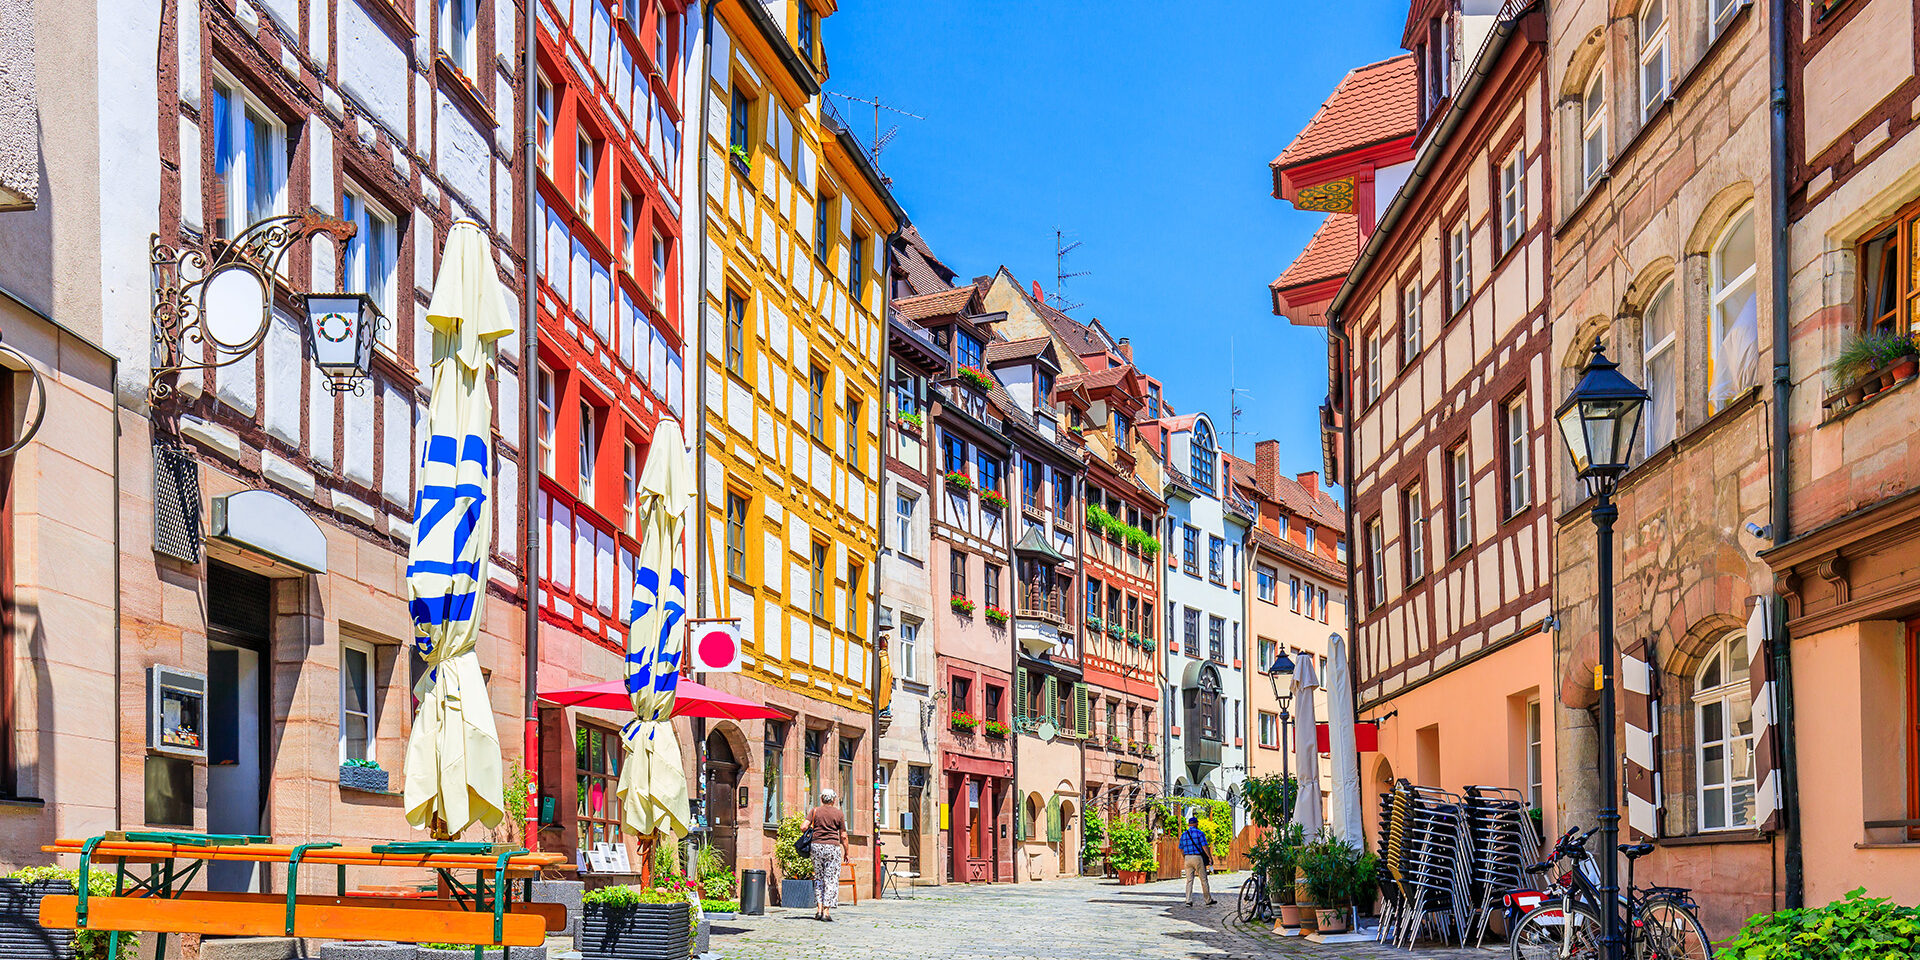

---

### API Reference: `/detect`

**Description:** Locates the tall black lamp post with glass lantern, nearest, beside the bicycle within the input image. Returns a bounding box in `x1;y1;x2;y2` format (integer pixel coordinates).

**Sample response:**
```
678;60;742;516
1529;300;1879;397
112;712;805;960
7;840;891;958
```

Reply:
1553;342;1647;960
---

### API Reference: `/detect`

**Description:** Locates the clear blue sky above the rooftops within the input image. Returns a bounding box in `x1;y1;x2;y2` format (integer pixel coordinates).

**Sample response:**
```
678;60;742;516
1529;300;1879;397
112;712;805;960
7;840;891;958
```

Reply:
822;0;1405;495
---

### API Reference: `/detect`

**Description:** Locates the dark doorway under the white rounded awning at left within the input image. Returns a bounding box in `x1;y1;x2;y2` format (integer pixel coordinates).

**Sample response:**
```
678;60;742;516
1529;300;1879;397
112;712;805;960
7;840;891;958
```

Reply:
207;561;273;893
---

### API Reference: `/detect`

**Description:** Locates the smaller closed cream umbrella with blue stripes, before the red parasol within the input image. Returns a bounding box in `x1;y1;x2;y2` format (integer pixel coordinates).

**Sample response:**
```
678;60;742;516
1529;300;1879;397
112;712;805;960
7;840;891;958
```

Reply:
620;420;693;845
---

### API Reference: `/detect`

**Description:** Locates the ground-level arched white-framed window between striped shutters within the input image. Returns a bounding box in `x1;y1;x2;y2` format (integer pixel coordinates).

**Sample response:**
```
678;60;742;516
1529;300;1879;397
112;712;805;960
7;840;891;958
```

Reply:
1693;630;1753;831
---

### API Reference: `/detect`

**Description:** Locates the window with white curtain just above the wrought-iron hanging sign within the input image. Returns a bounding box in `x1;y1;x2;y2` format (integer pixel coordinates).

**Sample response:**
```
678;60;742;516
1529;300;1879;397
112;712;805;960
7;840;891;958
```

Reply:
211;81;286;240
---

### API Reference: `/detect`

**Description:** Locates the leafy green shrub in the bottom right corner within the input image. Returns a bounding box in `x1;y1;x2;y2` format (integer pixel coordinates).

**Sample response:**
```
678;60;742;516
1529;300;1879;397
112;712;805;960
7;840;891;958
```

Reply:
1718;887;1920;960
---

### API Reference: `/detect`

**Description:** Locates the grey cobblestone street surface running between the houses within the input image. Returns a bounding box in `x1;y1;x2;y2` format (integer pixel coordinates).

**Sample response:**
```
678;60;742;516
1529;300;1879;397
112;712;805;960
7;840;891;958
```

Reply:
712;874;1505;960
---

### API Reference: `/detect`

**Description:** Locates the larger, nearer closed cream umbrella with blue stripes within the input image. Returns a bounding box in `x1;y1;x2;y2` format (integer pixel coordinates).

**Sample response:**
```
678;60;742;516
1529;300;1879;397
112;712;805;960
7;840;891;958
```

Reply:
403;221;513;839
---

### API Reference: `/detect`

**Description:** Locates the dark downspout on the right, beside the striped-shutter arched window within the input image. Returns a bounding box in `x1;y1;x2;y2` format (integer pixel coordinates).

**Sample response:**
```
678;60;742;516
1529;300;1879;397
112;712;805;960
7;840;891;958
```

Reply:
1766;0;1807;910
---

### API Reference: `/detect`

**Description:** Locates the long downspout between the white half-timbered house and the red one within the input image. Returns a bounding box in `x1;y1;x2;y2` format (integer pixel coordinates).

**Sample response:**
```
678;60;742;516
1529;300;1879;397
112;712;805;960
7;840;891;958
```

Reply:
520;2;545;851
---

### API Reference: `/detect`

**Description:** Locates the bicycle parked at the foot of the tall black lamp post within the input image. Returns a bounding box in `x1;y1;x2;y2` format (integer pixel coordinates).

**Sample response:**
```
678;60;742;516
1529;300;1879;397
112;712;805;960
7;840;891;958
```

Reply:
1509;828;1713;960
